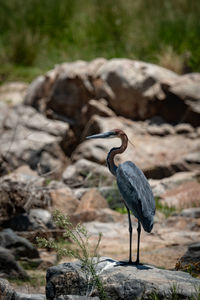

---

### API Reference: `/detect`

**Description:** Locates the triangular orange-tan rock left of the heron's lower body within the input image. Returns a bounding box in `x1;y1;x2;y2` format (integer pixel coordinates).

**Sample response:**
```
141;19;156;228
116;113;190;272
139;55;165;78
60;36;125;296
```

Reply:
76;189;108;213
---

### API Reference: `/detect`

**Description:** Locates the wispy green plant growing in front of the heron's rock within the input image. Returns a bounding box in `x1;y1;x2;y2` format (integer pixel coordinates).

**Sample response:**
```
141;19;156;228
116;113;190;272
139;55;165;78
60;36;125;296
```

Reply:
37;211;108;300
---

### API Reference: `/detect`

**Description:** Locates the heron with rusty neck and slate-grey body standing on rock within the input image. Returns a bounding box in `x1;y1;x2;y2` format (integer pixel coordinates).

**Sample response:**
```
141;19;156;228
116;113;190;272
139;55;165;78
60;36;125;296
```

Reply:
86;129;155;265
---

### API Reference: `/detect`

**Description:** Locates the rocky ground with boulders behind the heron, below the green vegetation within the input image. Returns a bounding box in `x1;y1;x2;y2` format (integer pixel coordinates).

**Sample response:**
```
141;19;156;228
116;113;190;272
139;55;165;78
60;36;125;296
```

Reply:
0;59;200;299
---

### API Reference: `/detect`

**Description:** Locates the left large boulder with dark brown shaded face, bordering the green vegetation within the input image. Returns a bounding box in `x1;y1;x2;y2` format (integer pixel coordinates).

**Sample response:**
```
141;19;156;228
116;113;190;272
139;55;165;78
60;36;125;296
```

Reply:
25;59;105;123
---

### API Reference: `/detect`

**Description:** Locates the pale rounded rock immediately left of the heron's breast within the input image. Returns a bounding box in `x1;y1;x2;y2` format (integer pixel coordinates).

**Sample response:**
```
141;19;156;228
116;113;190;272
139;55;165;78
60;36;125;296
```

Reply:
62;159;114;187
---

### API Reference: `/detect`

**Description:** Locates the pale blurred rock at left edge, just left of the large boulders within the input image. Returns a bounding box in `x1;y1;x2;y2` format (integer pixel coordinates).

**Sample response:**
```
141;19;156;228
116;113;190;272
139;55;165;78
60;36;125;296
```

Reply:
0;82;28;106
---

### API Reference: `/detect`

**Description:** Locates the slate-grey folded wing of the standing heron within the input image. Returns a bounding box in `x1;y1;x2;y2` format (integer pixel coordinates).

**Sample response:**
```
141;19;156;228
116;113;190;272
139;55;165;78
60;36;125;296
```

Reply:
116;161;155;219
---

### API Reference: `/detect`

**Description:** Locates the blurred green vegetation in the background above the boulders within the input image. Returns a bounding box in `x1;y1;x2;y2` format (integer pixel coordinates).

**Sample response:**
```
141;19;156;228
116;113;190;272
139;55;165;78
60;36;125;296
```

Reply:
0;0;200;82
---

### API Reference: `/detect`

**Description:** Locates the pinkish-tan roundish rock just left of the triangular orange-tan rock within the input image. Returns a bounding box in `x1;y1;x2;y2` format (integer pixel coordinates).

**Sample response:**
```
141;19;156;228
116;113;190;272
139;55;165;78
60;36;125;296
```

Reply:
50;187;80;215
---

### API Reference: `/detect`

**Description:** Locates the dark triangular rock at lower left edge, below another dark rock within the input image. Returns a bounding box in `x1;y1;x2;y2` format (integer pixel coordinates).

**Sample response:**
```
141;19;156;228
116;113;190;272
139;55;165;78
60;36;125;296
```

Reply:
0;247;29;279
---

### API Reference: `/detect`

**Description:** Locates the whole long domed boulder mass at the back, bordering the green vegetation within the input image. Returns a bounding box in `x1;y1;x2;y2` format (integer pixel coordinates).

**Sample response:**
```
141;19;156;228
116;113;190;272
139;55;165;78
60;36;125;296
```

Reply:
25;58;200;125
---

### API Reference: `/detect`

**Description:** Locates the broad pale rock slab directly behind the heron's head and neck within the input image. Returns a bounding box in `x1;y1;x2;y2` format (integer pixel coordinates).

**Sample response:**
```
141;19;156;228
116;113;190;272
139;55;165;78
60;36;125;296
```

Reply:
72;116;200;179
